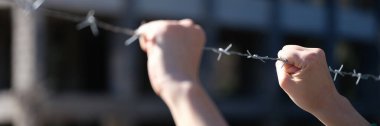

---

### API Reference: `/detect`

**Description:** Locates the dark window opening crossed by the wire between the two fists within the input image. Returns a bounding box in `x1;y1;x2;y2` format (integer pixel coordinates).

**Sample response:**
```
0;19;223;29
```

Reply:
211;28;268;98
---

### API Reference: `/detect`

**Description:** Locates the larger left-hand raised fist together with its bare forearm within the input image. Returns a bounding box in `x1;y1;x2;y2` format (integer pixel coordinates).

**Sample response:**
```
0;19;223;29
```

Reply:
137;19;227;126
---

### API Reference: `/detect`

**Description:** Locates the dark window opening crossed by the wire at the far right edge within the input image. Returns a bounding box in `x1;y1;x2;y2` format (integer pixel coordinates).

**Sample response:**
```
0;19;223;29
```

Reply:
335;41;380;102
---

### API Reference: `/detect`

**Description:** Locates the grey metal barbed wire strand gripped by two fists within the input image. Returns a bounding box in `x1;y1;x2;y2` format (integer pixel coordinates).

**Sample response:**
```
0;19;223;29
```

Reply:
15;0;380;85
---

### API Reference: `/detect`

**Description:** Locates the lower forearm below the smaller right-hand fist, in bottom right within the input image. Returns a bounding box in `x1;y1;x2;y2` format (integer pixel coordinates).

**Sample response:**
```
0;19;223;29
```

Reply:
311;96;370;126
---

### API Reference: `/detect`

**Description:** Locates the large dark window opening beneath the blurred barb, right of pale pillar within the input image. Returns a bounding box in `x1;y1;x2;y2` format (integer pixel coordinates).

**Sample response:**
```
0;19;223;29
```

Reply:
45;14;109;93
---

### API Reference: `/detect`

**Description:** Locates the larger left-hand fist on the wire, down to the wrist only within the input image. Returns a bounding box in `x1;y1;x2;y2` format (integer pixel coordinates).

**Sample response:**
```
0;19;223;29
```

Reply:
137;19;205;95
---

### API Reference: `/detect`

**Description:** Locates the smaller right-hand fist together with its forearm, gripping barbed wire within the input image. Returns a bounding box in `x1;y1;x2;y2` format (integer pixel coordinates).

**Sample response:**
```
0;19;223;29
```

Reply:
276;45;369;126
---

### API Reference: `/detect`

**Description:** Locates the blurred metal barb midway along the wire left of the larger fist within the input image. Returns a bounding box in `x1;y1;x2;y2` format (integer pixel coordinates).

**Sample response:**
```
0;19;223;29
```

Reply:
77;10;99;36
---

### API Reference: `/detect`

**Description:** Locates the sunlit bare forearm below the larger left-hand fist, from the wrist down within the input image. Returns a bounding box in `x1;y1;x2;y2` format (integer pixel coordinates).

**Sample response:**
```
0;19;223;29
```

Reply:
160;79;227;126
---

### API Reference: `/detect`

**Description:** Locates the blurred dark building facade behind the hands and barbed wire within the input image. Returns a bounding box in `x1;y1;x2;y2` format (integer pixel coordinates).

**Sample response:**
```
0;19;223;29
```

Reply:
0;0;380;126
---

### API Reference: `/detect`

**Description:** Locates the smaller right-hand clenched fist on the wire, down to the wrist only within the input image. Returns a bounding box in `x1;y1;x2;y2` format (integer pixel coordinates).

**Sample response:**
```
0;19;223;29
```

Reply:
276;45;340;111
